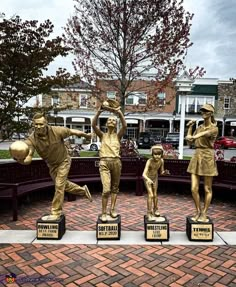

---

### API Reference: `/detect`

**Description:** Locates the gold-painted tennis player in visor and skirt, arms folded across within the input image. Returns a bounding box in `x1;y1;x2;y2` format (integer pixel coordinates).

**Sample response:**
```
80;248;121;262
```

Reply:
186;104;218;222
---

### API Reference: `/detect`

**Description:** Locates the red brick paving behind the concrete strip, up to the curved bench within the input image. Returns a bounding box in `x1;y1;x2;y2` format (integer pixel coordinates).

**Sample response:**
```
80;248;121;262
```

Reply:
0;192;236;231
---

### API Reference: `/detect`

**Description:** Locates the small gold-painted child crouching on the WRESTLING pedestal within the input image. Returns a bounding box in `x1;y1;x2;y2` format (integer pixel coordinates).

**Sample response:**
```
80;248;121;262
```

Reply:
143;145;169;221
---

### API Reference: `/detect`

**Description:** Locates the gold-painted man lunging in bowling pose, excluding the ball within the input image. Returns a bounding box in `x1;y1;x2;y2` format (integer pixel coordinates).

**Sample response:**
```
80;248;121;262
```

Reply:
10;113;92;221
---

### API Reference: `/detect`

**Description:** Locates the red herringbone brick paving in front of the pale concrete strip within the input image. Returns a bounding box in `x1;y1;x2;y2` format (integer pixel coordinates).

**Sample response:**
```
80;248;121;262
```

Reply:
0;244;236;287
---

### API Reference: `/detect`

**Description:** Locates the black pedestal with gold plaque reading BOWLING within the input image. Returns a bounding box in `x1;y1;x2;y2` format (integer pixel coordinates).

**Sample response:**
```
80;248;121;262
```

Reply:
36;215;66;240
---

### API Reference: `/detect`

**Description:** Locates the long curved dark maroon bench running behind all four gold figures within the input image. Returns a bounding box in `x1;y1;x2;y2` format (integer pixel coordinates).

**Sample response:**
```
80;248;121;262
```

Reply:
0;157;236;221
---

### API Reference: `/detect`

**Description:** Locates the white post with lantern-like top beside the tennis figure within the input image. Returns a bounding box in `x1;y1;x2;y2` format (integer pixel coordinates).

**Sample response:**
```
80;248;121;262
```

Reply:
175;71;194;159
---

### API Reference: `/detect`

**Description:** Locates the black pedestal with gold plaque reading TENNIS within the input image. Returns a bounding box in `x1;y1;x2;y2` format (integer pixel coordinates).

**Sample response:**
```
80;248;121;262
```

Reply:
186;216;214;241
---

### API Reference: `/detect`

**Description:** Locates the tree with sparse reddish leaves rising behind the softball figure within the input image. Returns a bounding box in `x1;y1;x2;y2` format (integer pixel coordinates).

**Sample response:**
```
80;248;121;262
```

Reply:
65;0;193;110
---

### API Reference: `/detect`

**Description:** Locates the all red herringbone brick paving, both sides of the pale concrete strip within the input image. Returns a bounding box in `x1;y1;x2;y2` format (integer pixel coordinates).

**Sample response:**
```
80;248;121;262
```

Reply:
0;192;236;287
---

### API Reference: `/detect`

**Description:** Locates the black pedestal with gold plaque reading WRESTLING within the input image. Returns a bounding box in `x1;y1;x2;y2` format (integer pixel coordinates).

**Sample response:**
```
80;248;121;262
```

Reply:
144;215;170;241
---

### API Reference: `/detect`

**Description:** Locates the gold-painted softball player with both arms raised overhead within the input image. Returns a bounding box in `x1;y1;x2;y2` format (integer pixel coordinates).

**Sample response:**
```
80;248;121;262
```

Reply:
92;104;127;222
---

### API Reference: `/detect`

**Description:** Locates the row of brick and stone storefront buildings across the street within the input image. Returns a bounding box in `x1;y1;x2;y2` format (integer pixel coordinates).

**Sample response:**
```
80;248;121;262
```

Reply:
42;75;236;142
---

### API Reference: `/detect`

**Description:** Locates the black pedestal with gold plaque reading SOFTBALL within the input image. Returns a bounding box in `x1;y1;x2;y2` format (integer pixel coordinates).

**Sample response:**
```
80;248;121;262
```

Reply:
96;215;121;240
